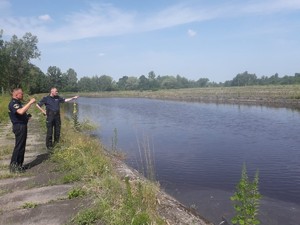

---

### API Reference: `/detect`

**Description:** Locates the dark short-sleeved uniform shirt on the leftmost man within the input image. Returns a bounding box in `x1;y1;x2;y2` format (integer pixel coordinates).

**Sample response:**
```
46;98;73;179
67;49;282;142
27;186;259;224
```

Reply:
8;98;28;124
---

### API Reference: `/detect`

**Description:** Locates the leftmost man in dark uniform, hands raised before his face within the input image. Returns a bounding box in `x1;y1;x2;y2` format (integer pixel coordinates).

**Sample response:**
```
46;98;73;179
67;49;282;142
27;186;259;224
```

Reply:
8;88;35;172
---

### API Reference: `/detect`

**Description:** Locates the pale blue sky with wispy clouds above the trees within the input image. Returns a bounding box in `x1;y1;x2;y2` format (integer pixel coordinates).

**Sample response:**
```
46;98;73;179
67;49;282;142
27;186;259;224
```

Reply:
0;0;300;82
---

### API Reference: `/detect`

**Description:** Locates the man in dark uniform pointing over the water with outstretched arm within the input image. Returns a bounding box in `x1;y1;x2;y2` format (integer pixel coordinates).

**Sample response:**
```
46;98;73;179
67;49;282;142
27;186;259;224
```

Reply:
36;87;78;149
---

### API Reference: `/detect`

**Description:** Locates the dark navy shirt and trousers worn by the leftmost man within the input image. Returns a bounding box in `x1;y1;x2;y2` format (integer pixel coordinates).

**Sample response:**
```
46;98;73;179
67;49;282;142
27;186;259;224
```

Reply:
8;99;30;169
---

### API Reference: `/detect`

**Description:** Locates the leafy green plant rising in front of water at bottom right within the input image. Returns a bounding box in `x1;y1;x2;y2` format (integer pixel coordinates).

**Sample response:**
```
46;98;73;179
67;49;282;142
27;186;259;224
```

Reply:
230;164;261;225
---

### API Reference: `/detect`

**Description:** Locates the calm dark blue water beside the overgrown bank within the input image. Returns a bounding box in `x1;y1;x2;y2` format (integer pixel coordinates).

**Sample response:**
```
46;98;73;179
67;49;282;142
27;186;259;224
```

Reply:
65;97;300;225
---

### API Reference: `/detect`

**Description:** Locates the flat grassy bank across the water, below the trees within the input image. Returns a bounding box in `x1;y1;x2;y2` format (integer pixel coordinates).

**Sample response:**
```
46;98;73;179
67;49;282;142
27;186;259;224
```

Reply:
80;85;300;108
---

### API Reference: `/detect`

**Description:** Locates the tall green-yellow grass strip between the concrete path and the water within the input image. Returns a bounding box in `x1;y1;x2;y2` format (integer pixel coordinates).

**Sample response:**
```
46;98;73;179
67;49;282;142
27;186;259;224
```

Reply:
51;115;164;225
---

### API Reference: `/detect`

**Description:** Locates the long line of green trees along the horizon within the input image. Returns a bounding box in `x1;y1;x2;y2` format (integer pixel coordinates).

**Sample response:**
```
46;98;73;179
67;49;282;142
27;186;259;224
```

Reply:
0;30;300;94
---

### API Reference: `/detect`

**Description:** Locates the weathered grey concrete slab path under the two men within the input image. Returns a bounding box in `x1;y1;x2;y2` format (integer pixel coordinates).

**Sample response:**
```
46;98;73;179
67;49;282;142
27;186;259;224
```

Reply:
0;118;88;225
